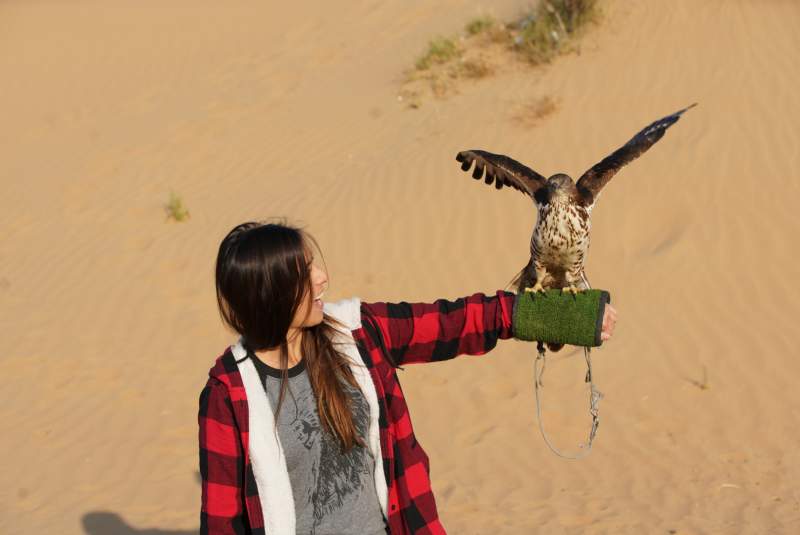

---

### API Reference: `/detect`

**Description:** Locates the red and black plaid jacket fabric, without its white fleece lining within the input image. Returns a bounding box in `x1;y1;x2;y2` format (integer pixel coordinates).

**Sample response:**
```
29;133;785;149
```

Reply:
198;291;515;535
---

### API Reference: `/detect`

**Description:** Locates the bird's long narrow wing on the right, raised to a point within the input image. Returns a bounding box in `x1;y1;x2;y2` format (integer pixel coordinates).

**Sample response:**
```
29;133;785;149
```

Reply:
576;103;697;205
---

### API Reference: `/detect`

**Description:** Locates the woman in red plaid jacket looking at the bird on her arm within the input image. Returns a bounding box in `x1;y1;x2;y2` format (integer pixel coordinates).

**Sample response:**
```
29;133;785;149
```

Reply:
198;223;615;535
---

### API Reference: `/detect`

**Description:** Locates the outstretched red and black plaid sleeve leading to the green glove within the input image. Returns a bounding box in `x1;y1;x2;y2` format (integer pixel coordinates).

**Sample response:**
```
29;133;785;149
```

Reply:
361;291;516;366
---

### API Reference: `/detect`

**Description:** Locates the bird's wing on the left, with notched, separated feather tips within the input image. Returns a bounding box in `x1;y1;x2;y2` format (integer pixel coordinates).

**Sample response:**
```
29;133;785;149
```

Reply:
456;150;547;197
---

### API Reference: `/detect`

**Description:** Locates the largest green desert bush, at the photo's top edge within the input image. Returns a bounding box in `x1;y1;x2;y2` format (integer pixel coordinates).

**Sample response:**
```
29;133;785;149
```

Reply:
514;0;598;63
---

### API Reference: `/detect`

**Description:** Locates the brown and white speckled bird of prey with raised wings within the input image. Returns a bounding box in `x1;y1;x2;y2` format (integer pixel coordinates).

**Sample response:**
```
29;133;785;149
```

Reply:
456;103;697;344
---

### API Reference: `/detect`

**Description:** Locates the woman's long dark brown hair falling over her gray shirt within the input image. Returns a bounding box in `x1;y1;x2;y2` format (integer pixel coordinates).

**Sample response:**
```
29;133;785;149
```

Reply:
216;222;365;451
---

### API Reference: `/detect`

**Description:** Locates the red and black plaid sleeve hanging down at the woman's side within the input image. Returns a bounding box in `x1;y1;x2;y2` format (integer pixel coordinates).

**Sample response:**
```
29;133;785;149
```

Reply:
198;377;249;535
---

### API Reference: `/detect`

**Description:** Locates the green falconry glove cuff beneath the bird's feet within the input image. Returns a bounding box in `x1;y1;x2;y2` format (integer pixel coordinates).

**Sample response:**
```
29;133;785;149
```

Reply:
512;290;611;347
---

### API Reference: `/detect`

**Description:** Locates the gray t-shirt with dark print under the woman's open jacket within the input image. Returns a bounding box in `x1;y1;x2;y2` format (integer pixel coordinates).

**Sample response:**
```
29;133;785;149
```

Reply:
250;352;388;535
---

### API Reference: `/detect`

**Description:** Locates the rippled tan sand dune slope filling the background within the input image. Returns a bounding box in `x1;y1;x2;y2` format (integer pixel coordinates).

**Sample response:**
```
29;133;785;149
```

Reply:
0;0;800;535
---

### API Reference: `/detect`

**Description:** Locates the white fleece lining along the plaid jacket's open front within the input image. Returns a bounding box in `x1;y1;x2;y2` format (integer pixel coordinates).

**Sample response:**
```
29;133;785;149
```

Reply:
231;298;388;535
